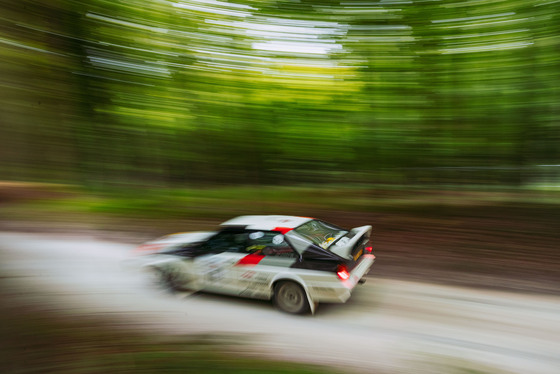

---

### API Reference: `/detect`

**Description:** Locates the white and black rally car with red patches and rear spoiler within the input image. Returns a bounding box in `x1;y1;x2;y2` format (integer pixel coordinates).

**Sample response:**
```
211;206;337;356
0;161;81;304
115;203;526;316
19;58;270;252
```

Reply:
132;215;375;314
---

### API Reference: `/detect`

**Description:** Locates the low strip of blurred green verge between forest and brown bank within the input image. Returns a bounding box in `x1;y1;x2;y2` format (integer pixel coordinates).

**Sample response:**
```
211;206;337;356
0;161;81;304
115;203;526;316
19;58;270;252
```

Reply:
0;184;560;235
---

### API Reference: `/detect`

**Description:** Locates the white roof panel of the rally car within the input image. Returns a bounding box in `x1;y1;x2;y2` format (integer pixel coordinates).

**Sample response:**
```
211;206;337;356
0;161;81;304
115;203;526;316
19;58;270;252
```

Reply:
222;215;313;232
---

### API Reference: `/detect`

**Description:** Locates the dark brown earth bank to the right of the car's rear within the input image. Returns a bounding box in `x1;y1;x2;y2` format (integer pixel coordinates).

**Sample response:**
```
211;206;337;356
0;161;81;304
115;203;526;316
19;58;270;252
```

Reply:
320;207;560;294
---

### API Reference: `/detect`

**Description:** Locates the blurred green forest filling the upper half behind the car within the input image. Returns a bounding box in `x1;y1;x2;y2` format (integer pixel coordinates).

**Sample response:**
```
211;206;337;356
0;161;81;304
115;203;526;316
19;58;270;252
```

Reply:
0;0;560;187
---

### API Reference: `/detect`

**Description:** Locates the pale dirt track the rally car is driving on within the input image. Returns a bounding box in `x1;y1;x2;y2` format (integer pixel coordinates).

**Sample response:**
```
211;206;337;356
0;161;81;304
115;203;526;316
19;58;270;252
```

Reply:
0;233;560;374
